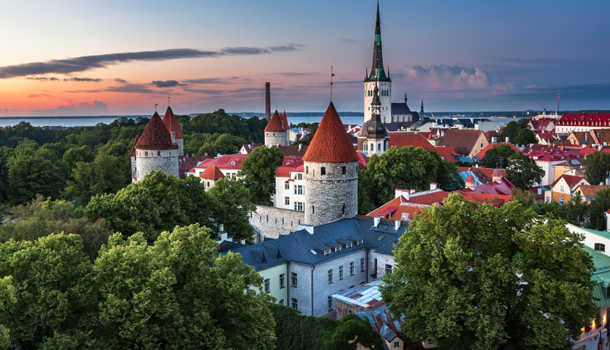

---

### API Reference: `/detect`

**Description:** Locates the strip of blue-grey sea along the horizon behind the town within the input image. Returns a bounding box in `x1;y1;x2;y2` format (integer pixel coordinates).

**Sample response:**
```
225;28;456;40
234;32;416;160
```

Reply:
0;112;513;127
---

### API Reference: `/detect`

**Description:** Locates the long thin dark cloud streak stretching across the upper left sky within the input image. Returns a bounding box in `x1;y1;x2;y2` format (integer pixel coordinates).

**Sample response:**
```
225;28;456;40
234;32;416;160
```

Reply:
0;44;303;80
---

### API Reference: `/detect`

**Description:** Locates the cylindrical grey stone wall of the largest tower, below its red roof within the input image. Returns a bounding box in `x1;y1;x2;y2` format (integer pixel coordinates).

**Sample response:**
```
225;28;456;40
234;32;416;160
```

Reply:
305;162;358;226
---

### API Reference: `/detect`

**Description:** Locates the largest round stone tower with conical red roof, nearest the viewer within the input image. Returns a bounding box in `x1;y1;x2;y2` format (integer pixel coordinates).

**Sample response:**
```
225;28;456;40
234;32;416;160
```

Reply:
303;102;358;226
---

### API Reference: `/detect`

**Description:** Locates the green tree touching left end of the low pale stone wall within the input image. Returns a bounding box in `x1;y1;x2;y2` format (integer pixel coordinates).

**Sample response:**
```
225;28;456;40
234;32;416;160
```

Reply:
208;178;256;243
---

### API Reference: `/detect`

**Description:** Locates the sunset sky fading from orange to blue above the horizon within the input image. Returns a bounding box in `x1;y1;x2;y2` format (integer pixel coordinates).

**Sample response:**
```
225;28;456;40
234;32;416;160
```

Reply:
0;0;610;117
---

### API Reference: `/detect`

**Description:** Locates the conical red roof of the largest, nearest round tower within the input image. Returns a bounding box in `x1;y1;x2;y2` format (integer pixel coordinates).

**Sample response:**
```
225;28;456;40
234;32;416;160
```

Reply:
303;102;358;163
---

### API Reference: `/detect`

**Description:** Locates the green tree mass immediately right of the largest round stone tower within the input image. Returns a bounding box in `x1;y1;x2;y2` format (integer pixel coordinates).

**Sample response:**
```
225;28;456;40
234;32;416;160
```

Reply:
358;147;464;214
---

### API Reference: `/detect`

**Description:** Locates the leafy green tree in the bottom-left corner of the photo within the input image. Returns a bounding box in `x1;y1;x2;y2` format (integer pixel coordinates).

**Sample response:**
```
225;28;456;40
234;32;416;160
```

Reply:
0;234;97;349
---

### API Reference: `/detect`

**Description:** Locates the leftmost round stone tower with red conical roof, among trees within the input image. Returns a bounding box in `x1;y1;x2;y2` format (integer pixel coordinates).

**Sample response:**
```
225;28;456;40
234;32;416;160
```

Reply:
135;112;180;181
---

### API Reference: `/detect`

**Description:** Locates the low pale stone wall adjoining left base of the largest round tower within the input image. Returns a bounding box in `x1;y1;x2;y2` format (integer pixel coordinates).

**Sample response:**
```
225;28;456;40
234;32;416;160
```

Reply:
250;205;305;239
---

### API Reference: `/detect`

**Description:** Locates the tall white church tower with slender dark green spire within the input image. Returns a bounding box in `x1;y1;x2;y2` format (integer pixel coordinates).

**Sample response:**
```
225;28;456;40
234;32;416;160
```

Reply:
364;1;392;123
